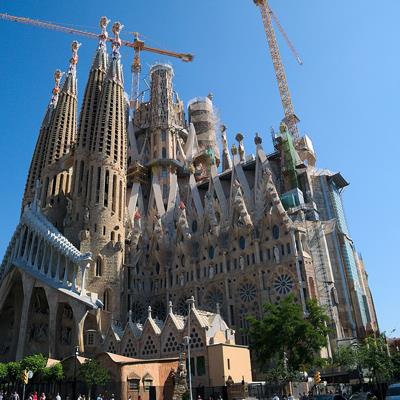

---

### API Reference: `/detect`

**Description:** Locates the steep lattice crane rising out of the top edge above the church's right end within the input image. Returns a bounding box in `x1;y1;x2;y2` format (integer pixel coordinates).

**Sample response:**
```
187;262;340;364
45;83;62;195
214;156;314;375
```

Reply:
253;0;303;140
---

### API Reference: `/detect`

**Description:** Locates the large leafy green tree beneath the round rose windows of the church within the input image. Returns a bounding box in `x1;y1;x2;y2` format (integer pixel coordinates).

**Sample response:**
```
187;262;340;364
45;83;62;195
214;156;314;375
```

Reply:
247;296;329;373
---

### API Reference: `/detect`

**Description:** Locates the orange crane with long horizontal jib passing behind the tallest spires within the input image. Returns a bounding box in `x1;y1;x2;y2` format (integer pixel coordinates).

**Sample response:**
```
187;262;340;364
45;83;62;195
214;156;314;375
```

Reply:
0;13;193;110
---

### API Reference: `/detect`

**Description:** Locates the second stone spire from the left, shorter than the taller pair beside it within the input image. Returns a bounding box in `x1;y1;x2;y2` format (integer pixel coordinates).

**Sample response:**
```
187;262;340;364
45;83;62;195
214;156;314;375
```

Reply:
40;41;80;232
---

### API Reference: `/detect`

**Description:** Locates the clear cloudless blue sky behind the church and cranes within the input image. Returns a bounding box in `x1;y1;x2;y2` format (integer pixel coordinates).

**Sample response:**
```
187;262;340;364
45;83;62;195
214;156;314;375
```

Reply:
0;0;400;335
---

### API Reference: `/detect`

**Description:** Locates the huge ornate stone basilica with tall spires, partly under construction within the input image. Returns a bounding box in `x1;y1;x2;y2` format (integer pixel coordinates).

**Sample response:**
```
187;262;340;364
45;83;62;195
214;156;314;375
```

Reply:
0;18;378;360
